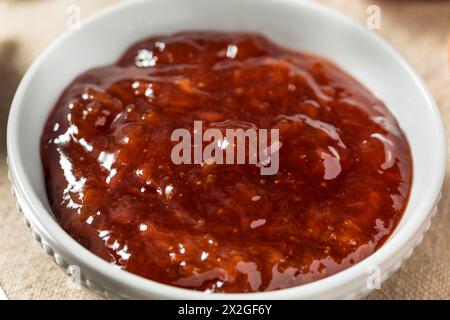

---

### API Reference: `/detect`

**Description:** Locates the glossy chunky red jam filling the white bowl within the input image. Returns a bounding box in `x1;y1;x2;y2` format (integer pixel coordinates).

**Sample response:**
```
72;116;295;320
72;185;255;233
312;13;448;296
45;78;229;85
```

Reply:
41;33;412;292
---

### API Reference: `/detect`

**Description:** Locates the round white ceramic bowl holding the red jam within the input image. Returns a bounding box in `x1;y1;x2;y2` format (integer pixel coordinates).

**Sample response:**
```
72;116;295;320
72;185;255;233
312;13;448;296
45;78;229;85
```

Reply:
7;0;445;299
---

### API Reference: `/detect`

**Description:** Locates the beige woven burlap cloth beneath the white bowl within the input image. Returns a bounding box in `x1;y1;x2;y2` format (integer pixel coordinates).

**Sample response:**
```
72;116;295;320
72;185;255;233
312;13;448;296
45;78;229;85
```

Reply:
0;0;450;299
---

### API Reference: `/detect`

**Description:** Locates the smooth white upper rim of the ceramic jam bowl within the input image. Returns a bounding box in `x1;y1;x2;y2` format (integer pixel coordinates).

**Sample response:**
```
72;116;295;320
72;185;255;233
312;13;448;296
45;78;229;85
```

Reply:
7;0;446;299
